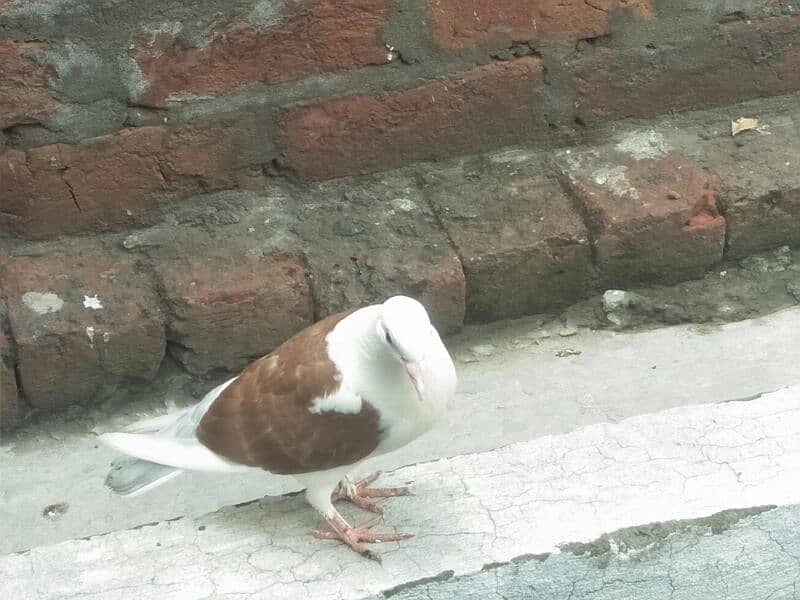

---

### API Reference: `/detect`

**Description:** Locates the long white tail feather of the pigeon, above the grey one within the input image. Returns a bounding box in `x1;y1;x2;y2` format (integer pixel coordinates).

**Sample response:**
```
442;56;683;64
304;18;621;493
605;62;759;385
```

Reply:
100;433;251;472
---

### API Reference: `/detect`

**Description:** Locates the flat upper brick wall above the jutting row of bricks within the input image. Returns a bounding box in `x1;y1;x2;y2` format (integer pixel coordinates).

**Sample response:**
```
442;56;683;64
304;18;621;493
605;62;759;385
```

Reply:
0;0;800;239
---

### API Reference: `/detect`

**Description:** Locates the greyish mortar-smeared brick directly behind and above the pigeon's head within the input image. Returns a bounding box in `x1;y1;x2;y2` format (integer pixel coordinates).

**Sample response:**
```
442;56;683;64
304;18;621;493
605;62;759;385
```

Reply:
296;174;465;333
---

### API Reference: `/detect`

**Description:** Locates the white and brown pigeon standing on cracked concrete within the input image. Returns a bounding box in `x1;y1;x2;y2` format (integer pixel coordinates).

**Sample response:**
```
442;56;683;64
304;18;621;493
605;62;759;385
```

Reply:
100;296;456;560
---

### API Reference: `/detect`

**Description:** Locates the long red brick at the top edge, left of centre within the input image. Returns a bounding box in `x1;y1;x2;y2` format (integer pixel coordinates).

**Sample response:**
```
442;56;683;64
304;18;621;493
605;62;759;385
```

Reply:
136;0;392;106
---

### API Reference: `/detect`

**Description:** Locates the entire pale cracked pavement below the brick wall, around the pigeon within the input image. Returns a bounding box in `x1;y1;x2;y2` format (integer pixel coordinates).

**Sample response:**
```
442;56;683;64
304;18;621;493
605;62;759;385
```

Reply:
0;309;800;599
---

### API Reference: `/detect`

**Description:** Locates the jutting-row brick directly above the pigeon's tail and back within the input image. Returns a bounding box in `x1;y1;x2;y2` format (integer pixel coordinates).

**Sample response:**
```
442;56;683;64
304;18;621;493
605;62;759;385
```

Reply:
150;222;314;374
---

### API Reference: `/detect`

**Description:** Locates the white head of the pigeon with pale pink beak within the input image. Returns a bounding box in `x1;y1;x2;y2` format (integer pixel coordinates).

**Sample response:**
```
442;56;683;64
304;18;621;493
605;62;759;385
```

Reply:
377;296;436;400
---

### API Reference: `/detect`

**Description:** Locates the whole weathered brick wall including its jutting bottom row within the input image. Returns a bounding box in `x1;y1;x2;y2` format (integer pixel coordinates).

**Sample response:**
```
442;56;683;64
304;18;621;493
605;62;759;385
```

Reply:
0;0;800;432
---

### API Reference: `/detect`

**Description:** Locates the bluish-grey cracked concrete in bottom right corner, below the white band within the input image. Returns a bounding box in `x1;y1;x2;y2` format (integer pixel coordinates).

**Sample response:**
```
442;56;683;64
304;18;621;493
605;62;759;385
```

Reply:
373;505;800;600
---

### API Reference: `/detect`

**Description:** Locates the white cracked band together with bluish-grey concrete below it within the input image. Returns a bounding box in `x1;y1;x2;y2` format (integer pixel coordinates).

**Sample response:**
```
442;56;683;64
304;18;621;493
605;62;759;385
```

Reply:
0;386;800;600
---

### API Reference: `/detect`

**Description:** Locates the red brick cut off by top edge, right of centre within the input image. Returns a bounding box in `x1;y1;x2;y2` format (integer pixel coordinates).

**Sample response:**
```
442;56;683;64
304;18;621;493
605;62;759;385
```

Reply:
429;0;653;49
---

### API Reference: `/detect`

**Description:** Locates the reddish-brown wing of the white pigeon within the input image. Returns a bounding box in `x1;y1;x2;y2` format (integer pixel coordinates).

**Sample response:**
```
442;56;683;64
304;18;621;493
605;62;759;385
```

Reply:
197;311;380;475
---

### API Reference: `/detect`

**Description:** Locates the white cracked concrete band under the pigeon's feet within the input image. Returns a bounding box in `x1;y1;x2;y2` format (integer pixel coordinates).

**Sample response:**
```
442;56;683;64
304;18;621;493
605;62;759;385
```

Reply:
0;387;800;600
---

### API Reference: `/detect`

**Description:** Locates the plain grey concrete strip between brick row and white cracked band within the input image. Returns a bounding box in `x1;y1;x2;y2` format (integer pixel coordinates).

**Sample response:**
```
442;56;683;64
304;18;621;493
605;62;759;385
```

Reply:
0;308;800;554
